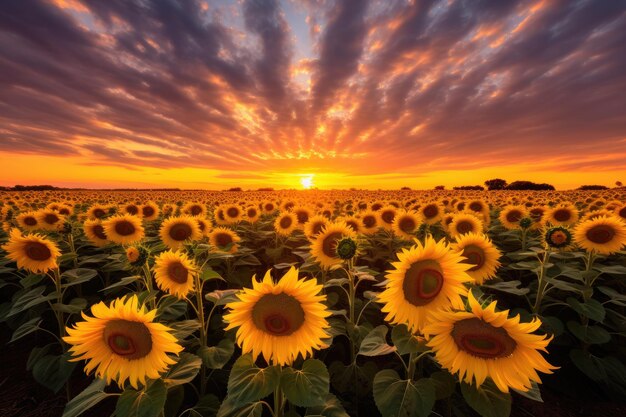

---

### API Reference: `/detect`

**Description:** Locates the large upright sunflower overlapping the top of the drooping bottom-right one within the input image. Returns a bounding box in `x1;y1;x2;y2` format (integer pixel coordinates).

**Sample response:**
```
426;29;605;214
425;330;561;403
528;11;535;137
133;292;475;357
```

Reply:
378;236;472;333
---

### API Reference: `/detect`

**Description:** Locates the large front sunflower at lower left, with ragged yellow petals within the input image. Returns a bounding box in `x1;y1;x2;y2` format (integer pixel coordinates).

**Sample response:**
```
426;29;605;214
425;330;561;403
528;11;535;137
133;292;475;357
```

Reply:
63;295;183;389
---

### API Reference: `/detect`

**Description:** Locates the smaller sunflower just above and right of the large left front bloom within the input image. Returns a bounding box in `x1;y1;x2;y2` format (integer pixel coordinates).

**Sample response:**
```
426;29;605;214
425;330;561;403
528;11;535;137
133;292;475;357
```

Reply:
153;250;198;299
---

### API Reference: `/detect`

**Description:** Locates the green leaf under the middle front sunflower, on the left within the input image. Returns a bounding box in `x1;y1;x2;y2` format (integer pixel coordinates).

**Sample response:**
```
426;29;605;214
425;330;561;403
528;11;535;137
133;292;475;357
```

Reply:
228;354;280;406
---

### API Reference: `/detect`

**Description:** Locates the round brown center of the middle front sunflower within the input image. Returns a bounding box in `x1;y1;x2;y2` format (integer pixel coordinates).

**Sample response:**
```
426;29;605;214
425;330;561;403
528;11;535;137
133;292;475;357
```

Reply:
252;293;304;336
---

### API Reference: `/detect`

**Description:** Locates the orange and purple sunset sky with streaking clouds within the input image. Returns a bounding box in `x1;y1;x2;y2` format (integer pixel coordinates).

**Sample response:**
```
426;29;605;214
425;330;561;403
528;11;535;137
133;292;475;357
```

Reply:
0;0;626;189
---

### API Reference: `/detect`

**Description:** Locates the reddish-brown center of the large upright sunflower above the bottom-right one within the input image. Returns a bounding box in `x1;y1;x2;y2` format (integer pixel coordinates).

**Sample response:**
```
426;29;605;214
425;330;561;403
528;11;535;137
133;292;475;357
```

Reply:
402;260;443;307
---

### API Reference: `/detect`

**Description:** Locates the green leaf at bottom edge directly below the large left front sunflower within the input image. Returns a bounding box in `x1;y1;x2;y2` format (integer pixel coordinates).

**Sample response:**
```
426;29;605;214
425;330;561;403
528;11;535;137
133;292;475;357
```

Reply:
115;379;167;417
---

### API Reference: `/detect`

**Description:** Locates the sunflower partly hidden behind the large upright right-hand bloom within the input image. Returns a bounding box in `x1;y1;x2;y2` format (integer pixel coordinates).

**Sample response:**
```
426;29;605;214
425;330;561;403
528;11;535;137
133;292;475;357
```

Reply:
452;233;502;285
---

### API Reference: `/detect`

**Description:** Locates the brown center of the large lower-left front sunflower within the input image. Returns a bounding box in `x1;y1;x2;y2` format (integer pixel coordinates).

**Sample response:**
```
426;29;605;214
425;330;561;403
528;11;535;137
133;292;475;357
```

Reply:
103;320;152;360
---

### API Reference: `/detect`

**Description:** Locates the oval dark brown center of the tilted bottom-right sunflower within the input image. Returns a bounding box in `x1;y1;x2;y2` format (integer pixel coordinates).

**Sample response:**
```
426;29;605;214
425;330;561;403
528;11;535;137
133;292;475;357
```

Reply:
451;318;517;359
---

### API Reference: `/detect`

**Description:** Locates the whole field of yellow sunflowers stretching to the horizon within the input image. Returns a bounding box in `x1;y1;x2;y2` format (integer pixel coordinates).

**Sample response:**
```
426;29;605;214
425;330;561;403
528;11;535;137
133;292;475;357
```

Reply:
0;189;626;417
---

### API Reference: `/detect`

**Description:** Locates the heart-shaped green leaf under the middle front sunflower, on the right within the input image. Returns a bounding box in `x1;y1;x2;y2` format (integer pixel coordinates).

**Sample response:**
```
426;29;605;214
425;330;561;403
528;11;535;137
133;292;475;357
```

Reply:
280;359;330;407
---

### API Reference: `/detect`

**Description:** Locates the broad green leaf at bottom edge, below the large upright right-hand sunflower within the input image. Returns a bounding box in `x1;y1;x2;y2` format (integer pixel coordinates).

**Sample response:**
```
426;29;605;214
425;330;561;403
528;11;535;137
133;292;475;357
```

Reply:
374;369;435;417
